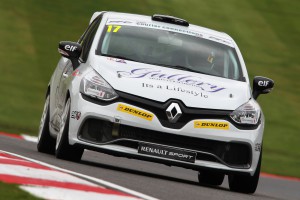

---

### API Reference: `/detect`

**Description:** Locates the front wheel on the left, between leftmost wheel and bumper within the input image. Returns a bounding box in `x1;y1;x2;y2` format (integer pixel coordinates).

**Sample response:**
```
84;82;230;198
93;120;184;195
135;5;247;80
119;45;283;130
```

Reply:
55;98;84;162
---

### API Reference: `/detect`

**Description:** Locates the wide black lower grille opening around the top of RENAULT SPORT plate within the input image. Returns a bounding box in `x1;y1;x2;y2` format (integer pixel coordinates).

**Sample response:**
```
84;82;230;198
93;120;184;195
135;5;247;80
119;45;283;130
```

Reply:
79;119;252;168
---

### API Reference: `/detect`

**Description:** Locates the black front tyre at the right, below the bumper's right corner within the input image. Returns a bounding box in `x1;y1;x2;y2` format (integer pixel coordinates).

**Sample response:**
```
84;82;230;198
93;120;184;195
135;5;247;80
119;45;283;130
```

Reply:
228;151;262;194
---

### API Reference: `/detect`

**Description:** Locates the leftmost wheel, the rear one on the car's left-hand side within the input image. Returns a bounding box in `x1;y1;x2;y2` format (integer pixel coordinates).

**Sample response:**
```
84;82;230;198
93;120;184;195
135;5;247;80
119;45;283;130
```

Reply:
37;94;55;154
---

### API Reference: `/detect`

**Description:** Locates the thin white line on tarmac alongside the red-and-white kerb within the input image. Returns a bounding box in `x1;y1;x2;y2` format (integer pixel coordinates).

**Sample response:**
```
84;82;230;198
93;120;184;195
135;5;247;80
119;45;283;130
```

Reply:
0;150;158;200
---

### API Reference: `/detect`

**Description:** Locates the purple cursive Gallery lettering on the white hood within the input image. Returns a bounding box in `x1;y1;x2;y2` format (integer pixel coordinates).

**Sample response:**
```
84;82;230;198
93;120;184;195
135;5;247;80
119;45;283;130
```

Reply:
117;68;225;93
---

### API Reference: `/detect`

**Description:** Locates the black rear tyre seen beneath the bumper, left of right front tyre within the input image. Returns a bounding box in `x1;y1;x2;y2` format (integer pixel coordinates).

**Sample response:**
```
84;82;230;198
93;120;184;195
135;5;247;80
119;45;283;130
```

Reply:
198;170;225;186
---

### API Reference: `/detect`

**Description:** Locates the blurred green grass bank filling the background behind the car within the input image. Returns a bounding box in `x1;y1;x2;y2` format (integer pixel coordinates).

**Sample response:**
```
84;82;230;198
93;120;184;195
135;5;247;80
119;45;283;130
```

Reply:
0;0;300;177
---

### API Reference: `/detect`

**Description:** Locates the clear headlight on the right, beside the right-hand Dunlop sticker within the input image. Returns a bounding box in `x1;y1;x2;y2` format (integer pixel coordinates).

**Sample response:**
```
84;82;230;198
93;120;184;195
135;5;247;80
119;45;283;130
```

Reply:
230;99;260;125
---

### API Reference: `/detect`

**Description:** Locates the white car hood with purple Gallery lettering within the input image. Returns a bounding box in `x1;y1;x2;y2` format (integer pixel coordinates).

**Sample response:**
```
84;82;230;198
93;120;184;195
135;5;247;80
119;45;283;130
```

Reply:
91;56;250;110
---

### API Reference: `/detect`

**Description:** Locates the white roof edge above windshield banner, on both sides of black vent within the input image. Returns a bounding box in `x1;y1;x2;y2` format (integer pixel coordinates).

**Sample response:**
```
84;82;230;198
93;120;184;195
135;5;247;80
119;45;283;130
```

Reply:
90;11;235;46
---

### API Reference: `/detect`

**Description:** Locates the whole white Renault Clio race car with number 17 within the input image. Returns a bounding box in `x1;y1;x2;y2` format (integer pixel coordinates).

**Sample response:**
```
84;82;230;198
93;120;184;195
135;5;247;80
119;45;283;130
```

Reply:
37;12;274;193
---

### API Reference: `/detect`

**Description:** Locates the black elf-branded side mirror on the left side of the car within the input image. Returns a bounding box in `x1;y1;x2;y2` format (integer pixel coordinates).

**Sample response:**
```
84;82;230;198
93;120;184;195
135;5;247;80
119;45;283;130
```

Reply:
58;41;82;69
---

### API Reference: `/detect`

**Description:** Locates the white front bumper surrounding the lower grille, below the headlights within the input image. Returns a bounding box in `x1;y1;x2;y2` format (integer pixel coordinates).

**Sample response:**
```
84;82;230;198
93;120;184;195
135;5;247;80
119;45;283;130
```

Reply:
69;94;263;175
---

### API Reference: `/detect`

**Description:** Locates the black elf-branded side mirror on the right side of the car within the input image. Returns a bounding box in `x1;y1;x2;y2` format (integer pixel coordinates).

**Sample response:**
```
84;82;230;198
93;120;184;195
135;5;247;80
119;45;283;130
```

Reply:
252;76;274;99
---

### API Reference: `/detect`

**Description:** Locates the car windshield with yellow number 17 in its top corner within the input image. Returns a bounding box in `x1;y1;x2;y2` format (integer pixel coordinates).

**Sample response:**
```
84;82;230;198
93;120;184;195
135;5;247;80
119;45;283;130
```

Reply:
97;25;243;80
